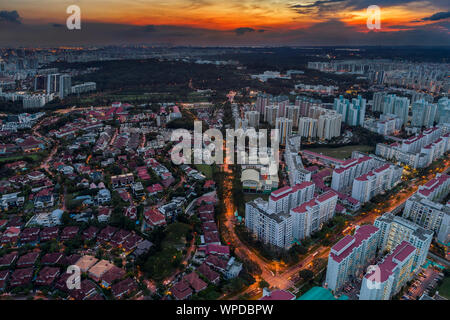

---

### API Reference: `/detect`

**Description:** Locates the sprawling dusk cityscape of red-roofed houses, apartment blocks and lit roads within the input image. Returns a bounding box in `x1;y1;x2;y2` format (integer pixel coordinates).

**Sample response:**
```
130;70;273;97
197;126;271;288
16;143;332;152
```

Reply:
0;46;450;301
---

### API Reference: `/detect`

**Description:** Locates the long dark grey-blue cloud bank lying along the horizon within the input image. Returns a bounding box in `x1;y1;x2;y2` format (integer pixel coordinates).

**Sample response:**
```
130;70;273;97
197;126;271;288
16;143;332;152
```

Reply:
0;20;450;47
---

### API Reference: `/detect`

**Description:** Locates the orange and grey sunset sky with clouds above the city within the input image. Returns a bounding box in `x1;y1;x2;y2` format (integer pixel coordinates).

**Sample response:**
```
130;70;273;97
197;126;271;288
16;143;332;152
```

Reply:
0;0;450;47
